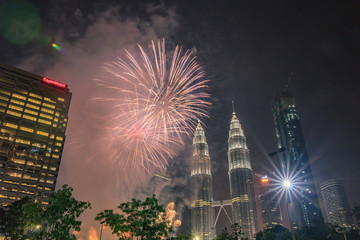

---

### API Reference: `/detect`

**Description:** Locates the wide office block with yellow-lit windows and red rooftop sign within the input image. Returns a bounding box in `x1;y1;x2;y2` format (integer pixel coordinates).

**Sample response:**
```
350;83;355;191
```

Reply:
0;64;71;206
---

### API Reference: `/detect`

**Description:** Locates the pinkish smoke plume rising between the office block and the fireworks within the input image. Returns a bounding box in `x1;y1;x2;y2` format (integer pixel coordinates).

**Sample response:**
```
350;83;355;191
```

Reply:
17;1;186;240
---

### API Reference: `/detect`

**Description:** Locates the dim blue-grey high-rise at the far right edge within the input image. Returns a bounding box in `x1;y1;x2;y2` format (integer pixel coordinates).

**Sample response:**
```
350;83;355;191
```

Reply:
320;180;355;229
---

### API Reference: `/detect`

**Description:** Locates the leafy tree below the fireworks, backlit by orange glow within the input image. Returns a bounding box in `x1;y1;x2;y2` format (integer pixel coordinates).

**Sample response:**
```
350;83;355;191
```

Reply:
95;195;173;239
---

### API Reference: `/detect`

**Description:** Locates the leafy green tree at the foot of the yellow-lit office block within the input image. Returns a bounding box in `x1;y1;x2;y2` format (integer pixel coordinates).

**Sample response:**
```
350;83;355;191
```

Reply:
0;185;91;240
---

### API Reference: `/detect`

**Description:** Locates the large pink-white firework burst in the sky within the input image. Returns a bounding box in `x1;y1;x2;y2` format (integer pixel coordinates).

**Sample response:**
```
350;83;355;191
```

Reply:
96;40;211;177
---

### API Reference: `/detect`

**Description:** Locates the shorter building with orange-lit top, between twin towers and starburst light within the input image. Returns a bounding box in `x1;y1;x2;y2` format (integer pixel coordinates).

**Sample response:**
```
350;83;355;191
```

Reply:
259;176;282;229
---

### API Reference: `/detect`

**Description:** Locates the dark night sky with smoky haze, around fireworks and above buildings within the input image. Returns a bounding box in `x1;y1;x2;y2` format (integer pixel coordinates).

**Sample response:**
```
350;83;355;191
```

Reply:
0;0;360;239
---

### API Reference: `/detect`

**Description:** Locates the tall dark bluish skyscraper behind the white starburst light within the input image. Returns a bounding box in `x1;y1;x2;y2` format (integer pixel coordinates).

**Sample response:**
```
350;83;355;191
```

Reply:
272;91;322;227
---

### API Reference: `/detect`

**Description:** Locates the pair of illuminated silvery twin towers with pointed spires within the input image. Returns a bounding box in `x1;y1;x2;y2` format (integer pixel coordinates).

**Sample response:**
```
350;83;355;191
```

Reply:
191;112;258;240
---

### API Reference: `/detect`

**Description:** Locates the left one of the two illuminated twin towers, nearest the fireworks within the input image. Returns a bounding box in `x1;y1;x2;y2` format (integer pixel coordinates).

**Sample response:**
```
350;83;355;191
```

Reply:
191;122;215;240
